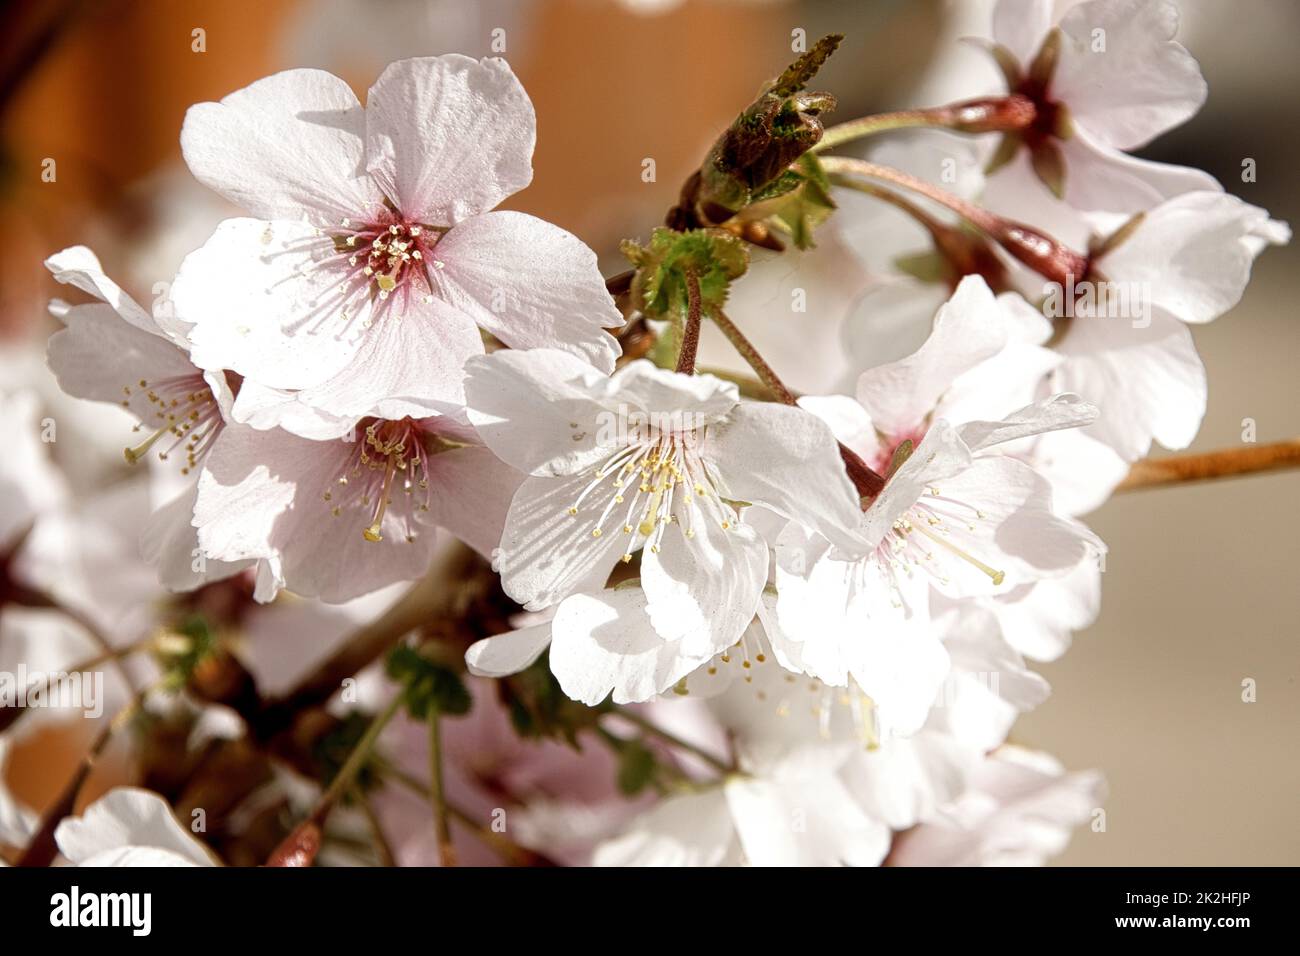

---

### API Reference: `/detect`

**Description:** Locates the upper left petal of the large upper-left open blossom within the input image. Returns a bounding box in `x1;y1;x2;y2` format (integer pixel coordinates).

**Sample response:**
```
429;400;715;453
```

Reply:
181;70;384;226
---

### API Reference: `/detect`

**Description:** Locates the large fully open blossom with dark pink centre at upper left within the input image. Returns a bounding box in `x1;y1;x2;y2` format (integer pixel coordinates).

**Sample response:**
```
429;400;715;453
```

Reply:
173;53;623;437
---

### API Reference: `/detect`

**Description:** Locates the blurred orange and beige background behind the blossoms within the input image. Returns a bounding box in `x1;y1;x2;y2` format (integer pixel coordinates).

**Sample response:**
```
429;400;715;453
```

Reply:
0;0;1300;865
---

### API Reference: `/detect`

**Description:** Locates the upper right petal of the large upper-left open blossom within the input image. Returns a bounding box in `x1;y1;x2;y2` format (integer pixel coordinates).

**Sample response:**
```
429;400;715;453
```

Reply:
365;53;537;226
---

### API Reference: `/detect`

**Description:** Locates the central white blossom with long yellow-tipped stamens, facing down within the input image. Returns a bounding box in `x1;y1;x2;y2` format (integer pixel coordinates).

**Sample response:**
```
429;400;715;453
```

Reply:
465;350;858;657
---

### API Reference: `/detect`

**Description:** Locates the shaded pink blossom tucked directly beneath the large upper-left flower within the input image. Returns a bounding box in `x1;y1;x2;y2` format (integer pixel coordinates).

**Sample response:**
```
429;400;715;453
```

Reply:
194;416;519;602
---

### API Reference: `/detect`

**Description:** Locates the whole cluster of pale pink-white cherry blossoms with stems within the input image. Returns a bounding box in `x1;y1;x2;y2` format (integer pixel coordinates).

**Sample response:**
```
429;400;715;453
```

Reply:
0;0;1290;865
